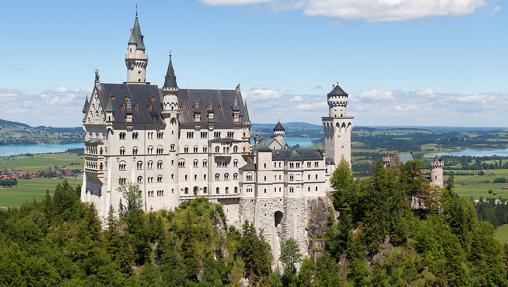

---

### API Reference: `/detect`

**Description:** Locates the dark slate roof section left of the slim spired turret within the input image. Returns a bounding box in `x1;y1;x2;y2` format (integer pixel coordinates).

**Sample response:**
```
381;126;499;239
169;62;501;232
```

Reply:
98;83;163;125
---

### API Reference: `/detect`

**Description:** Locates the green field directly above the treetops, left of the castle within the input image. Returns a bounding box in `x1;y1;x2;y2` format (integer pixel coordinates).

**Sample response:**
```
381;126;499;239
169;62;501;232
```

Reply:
0;177;81;208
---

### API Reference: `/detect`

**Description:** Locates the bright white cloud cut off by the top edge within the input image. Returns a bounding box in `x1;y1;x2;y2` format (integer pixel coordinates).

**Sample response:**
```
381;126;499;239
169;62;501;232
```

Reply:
201;0;486;21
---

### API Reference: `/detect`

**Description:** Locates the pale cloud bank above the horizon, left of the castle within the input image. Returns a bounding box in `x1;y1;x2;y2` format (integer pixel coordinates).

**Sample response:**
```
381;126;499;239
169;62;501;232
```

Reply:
0;87;91;126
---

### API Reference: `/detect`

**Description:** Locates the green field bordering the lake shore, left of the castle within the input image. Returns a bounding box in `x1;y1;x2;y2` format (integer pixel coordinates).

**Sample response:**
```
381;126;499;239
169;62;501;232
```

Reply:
0;153;83;171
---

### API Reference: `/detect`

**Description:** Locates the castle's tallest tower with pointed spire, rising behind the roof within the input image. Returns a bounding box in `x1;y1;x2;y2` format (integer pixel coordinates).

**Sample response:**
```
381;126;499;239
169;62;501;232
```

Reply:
125;11;148;84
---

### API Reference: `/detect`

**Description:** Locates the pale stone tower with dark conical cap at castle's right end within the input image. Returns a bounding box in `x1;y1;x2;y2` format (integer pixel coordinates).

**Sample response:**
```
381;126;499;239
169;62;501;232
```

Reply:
322;84;353;165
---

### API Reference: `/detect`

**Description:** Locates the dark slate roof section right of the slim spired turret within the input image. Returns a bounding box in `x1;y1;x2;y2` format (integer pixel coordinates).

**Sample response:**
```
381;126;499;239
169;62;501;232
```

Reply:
178;89;246;125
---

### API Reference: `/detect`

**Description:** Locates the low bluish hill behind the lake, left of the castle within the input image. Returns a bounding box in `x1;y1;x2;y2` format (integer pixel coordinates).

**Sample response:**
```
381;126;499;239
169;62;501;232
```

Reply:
0;119;84;145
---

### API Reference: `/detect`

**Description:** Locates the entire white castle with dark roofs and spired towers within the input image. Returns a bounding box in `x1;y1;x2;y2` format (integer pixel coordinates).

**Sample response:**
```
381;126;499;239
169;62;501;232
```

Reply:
81;13;353;258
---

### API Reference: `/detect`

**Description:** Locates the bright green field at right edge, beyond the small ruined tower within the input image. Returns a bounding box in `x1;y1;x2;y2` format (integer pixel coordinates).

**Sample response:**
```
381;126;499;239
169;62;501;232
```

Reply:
448;169;508;199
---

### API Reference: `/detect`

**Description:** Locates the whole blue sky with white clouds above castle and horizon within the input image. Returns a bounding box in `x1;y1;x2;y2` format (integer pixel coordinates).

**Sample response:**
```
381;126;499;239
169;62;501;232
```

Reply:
0;0;508;126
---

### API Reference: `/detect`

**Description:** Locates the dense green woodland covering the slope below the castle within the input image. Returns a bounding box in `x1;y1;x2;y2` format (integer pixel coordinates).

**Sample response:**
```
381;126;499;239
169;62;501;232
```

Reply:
0;161;508;286
